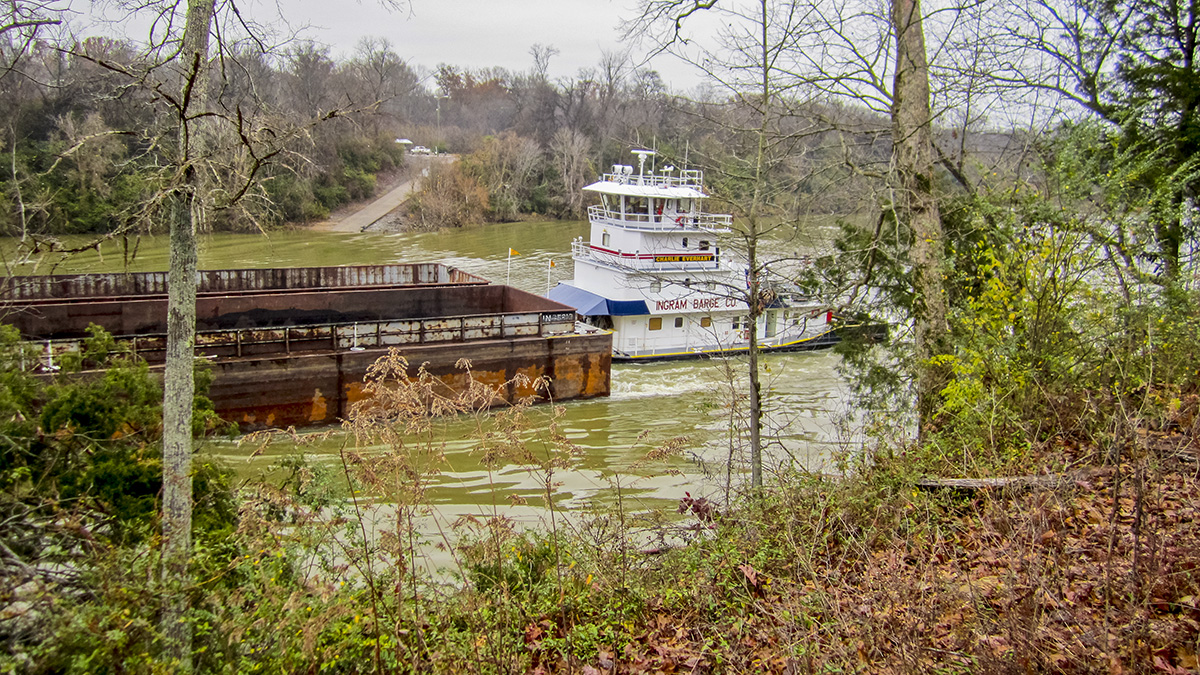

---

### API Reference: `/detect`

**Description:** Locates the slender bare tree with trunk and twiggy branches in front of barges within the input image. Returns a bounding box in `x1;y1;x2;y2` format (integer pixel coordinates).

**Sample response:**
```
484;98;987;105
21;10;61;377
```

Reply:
66;0;398;673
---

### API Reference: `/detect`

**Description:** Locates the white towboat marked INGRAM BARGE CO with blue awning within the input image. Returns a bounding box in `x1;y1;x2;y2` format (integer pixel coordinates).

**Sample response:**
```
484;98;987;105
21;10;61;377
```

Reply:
550;150;839;360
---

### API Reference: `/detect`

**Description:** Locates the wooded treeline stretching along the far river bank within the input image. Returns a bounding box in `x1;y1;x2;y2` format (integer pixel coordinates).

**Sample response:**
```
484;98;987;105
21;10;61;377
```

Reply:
0;33;993;235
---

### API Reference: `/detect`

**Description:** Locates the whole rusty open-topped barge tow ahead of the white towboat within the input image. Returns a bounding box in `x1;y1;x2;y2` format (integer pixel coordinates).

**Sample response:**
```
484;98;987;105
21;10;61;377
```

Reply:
0;263;612;428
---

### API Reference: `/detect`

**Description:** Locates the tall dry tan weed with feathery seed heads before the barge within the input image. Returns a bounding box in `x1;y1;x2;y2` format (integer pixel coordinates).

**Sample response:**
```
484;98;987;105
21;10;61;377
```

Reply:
342;350;588;670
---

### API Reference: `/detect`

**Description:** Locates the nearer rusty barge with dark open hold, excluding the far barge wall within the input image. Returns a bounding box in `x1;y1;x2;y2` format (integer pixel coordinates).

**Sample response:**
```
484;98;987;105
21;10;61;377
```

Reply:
0;277;612;430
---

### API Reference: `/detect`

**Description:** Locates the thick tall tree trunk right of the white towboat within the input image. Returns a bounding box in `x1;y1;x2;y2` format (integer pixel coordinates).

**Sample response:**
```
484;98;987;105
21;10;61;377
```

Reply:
892;0;947;434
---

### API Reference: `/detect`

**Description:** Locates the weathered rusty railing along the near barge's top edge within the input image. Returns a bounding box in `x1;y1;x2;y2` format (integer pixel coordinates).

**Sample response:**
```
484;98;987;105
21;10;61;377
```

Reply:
22;311;575;372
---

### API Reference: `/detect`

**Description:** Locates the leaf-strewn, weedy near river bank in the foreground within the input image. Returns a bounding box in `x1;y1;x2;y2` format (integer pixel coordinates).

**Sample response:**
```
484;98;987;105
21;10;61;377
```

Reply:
7;391;1200;675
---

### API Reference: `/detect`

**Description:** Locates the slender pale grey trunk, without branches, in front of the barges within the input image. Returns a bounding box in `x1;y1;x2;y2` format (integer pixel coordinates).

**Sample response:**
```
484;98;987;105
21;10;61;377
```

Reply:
162;0;215;673
